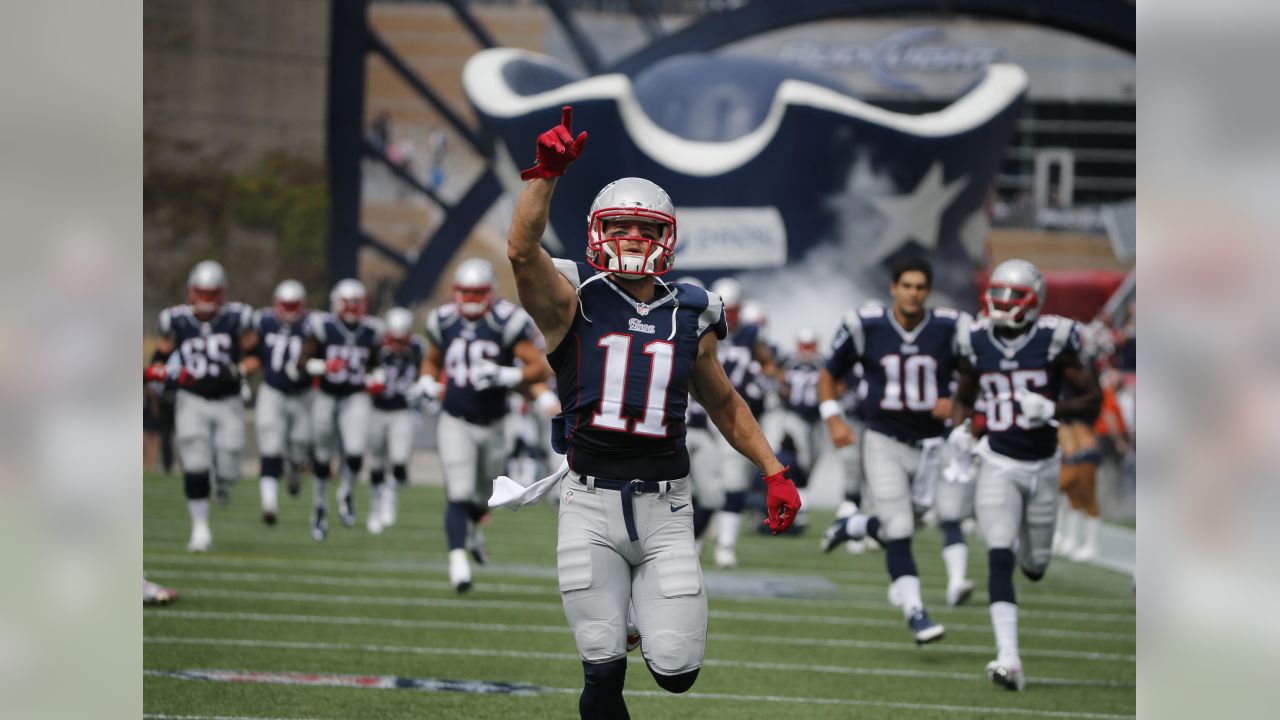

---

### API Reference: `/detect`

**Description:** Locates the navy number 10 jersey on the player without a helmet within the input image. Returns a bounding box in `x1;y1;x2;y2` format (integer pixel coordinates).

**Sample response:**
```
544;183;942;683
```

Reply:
827;306;968;443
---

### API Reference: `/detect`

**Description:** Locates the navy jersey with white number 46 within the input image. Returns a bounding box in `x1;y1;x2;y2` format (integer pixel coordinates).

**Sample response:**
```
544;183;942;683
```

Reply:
426;300;541;425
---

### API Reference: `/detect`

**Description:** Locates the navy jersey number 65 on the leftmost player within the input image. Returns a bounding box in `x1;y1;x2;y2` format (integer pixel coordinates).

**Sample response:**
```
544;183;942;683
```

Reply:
157;302;253;398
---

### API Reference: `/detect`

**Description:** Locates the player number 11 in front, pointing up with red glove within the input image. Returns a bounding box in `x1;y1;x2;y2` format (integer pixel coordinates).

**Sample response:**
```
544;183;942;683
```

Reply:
507;108;800;719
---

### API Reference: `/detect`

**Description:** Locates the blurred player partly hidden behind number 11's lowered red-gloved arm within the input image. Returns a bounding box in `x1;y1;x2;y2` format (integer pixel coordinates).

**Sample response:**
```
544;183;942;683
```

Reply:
712;278;777;568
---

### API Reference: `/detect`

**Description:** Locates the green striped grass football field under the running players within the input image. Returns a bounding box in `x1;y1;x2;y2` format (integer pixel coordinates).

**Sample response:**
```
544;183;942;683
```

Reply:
143;474;1135;720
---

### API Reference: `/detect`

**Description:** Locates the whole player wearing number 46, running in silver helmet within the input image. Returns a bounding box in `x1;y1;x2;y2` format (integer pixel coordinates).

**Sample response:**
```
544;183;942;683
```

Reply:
419;258;552;592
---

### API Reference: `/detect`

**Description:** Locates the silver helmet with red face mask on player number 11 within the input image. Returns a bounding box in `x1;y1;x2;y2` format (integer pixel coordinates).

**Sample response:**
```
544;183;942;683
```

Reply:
586;178;676;278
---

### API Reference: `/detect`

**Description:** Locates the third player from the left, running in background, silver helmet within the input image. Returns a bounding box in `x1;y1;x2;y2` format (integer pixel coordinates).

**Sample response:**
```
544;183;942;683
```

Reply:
302;278;383;542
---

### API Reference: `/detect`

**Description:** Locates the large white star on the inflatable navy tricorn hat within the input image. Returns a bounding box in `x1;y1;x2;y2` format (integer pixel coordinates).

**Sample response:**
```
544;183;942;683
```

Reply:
868;160;969;261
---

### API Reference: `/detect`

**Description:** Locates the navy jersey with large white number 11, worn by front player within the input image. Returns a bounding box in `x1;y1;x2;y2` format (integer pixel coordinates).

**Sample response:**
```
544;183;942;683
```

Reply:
547;260;727;480
